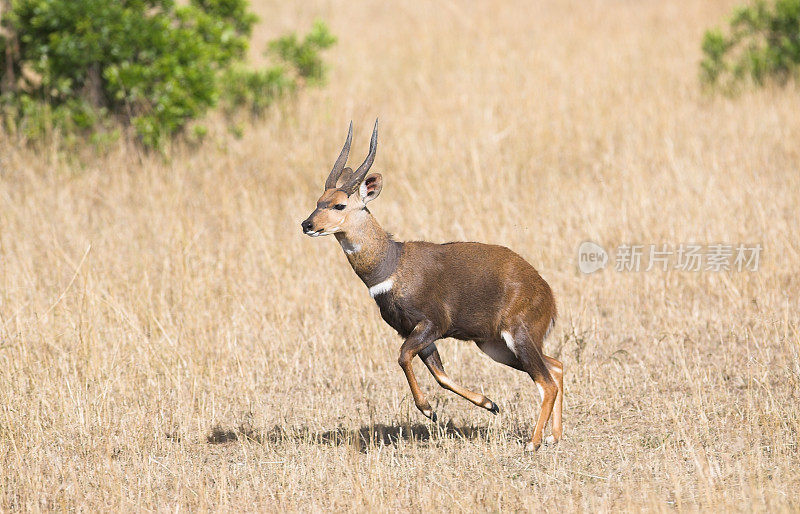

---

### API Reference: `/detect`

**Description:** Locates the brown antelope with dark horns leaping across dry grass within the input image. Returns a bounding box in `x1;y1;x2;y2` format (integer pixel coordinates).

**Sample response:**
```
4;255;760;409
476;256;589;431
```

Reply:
301;119;564;451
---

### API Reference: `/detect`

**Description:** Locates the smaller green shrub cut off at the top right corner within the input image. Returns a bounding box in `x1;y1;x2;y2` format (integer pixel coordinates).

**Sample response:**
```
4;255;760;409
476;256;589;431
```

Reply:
700;0;800;90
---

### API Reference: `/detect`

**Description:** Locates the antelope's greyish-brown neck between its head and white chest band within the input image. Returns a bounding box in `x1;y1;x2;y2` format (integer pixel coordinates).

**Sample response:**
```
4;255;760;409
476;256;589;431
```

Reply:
336;210;402;287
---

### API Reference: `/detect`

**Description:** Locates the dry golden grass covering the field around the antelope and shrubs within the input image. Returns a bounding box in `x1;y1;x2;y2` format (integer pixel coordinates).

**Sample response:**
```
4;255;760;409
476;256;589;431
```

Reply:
0;0;800;511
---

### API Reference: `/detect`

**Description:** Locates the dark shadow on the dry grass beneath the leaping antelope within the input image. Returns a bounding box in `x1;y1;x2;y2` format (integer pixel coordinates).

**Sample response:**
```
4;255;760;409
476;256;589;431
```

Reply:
206;421;518;451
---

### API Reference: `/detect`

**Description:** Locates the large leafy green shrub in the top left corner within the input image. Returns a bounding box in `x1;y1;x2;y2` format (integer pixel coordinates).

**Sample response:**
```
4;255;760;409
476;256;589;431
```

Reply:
0;0;335;147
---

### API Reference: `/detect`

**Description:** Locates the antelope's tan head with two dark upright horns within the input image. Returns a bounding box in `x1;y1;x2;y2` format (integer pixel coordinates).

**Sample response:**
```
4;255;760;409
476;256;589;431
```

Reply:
300;119;383;237
